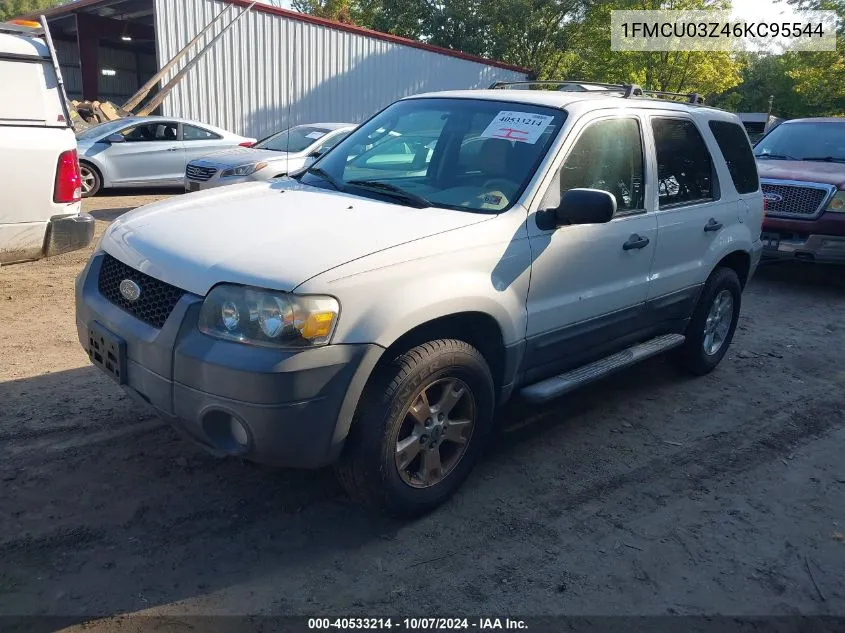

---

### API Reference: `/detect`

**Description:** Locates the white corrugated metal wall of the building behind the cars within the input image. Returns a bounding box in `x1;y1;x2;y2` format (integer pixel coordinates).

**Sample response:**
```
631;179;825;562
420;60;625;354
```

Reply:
155;0;525;137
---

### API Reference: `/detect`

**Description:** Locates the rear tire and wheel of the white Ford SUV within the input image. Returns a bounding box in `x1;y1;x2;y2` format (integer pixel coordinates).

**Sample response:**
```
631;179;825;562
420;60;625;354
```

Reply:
676;268;742;376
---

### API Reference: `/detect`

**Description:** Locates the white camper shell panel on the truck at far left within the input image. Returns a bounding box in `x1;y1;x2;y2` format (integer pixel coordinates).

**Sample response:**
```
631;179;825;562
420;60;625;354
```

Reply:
0;58;66;126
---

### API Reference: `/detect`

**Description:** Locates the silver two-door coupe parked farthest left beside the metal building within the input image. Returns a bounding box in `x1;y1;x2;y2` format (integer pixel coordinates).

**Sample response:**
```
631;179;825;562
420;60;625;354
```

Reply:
76;117;255;198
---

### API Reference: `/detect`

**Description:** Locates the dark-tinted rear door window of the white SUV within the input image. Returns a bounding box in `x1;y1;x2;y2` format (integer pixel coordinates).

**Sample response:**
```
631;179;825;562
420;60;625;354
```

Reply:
651;118;717;207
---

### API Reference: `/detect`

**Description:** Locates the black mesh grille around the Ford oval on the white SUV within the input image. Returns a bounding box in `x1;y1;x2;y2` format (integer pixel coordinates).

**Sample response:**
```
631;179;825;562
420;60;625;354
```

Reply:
97;254;185;330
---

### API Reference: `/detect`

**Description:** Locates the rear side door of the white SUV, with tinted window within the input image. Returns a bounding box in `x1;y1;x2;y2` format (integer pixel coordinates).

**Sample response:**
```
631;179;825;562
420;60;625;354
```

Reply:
647;111;739;312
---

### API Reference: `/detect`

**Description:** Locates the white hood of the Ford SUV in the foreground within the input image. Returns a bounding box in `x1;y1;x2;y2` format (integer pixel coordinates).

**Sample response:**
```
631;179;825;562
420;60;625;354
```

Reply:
102;179;495;295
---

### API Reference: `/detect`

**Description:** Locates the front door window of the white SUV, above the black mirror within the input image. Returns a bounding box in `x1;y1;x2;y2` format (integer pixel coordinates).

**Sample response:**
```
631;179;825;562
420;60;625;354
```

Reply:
543;118;645;215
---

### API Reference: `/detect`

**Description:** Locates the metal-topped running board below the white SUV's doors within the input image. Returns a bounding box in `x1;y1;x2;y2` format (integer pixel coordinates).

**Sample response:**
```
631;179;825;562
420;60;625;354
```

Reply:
520;334;686;402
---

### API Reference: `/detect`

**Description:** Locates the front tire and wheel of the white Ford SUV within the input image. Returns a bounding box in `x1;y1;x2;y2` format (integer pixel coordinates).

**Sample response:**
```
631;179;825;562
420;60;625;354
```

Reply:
335;340;495;518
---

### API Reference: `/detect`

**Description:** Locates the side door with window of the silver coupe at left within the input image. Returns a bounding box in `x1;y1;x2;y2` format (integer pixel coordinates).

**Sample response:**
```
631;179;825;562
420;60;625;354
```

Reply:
103;121;185;186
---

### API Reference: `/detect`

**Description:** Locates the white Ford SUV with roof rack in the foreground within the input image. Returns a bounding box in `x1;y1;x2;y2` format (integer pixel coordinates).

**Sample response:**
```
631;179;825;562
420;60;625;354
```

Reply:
76;81;763;515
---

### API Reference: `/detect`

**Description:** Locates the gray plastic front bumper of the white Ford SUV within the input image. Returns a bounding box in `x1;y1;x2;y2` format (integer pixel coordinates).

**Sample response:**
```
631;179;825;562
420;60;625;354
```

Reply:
76;253;383;468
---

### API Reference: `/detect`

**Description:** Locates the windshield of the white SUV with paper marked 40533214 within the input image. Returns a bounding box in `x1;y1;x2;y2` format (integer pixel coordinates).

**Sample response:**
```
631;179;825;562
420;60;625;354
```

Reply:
299;98;566;213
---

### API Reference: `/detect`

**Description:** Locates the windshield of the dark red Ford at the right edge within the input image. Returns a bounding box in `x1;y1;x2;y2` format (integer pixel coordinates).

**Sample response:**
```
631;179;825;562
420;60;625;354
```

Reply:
754;119;845;162
